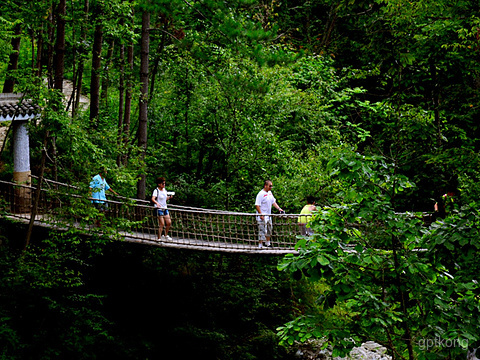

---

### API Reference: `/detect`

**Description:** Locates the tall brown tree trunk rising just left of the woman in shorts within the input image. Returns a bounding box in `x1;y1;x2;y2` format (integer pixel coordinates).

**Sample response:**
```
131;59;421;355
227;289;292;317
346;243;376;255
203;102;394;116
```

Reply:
137;10;150;199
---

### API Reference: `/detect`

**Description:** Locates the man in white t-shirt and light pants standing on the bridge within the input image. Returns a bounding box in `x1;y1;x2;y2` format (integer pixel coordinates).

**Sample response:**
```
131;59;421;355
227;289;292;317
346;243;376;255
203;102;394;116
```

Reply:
255;180;284;248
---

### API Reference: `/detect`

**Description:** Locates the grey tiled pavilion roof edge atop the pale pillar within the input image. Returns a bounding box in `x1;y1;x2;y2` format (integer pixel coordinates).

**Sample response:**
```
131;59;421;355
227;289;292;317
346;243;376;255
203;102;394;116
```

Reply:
0;94;40;121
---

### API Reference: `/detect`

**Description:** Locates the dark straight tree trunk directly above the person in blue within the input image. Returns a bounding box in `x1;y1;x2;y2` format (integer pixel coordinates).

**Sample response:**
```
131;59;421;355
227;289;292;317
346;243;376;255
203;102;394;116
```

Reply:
90;3;103;127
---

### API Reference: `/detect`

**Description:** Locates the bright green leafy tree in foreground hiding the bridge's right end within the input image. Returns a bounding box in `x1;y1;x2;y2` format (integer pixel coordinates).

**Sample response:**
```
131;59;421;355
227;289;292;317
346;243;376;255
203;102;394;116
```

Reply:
279;154;480;359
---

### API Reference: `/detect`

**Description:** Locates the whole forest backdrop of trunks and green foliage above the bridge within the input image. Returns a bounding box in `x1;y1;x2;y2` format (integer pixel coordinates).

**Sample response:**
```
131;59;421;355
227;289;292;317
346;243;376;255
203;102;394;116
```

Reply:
0;0;479;212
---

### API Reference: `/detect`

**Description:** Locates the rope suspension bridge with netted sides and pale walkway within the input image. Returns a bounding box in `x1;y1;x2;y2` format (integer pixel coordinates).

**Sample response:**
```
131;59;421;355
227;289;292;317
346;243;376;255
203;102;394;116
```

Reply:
0;181;304;255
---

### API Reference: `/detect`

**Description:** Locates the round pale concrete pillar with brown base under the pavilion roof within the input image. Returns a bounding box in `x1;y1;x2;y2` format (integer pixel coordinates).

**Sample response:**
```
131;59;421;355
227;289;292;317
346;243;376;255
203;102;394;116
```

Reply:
13;120;32;213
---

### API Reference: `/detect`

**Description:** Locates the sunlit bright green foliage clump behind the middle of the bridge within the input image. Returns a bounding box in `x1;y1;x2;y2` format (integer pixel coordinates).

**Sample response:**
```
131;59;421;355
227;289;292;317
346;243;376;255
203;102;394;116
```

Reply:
147;50;348;209
